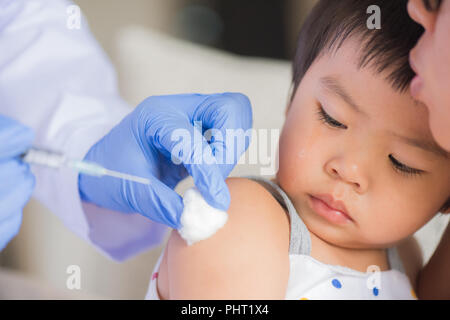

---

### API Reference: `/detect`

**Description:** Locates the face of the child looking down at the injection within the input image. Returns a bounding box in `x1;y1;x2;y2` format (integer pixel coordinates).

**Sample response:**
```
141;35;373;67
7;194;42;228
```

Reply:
277;40;450;248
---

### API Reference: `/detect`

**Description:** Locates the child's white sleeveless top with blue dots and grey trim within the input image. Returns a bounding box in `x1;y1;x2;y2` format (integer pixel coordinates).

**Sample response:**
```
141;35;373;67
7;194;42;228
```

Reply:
146;176;417;300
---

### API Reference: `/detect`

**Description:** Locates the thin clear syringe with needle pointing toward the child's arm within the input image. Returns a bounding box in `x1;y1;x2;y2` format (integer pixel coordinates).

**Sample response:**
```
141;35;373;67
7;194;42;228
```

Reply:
21;148;150;184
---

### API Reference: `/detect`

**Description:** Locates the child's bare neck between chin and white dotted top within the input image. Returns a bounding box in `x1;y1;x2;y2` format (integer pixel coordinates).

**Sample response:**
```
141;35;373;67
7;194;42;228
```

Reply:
310;232;389;272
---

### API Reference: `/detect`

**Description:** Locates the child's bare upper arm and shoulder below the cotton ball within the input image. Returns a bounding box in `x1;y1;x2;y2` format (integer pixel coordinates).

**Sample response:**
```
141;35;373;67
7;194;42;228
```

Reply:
167;178;289;299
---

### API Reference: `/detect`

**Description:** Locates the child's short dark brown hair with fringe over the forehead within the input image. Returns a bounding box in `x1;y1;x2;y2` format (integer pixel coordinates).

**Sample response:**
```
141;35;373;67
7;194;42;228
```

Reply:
291;0;450;212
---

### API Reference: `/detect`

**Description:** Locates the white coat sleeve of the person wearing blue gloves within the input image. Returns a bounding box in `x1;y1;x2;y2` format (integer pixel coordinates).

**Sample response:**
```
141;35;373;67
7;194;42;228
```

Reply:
0;0;167;260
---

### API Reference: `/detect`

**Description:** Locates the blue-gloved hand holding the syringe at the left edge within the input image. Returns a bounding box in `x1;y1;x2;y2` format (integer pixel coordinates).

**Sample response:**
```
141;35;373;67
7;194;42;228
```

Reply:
0;115;35;250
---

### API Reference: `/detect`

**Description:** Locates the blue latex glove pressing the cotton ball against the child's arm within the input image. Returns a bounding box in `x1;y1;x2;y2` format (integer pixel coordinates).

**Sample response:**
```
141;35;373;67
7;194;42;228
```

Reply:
79;93;252;229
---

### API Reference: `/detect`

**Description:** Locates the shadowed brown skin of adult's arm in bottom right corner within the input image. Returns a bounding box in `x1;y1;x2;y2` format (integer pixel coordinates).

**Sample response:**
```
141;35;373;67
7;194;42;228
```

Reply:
417;224;450;299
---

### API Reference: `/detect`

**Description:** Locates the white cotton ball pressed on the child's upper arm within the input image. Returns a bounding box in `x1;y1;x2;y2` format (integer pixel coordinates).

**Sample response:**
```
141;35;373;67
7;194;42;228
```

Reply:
178;186;228;245
